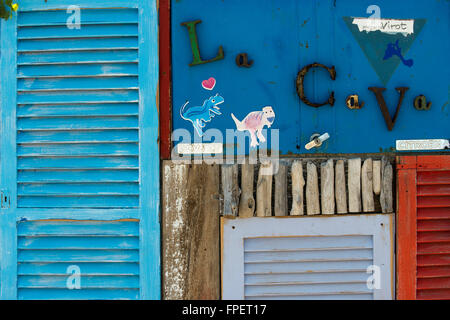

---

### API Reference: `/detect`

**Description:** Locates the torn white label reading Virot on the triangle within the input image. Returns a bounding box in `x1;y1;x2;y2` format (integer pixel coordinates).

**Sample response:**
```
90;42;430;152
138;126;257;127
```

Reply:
353;18;414;36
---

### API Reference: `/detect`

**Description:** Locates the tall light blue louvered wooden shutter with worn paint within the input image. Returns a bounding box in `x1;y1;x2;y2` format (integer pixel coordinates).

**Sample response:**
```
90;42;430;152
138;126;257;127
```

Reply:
1;0;160;299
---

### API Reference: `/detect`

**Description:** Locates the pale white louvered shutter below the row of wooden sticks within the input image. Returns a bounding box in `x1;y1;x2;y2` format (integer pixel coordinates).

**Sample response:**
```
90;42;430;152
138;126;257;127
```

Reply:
222;214;393;300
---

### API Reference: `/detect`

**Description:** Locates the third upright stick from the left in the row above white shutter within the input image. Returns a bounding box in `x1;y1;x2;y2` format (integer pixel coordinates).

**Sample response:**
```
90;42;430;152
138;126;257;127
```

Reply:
256;161;273;217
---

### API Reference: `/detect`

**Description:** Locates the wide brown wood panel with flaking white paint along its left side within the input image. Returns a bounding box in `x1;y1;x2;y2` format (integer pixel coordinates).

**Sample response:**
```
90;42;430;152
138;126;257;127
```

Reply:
162;161;220;300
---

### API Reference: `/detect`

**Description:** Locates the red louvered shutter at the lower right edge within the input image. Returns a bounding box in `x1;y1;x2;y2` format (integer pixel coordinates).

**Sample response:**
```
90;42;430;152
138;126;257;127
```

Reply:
397;155;450;300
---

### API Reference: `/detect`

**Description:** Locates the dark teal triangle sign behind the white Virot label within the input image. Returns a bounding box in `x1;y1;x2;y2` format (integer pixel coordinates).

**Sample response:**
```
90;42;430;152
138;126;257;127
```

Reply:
343;17;426;85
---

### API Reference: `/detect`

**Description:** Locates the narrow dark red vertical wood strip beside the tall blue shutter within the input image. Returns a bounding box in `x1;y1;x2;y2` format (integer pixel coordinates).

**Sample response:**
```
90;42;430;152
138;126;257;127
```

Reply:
159;0;172;159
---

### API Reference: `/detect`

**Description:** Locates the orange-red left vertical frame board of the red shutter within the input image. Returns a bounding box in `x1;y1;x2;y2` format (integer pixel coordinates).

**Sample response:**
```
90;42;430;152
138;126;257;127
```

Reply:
397;166;417;300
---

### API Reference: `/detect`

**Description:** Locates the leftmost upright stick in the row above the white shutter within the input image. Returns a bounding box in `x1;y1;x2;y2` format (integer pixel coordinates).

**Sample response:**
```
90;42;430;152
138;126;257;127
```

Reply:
222;164;240;216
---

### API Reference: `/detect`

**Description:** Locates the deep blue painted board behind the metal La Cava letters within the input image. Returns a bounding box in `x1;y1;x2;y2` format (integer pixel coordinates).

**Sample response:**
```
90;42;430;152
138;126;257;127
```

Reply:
172;0;450;154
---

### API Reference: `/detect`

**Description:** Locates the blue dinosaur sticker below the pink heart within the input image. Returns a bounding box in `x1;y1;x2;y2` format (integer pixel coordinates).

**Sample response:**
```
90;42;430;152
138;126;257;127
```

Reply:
180;94;225;137
